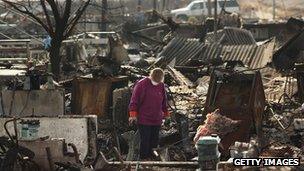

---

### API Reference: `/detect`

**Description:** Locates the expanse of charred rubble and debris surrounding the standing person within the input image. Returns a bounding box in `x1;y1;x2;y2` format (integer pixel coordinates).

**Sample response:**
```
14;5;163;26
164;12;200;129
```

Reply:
0;2;304;171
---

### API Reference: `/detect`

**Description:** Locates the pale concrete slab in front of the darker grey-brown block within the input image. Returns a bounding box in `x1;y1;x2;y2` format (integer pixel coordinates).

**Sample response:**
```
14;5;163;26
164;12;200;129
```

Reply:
0;115;97;161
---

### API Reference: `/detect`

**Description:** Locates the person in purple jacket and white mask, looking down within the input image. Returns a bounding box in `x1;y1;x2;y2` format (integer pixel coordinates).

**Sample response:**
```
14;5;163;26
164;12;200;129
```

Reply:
129;68;169;160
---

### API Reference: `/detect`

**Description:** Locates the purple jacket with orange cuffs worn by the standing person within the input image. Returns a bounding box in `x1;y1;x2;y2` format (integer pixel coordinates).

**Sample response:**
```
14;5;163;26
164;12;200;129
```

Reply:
129;77;169;125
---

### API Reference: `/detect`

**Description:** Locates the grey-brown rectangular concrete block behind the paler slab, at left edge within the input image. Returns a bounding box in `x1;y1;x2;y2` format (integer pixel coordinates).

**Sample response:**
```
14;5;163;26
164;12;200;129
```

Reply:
1;89;65;116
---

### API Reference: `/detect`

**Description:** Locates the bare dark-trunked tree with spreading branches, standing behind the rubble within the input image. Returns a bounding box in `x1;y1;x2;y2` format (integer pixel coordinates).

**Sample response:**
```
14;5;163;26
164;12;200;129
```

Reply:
2;0;90;78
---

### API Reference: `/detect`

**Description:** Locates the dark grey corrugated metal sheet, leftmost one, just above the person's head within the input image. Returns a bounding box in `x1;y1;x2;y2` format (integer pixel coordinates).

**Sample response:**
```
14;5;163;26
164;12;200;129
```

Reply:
158;37;204;66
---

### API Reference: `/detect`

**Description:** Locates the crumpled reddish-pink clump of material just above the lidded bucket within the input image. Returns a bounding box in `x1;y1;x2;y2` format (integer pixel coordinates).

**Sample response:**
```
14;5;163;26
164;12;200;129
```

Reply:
194;109;241;142
